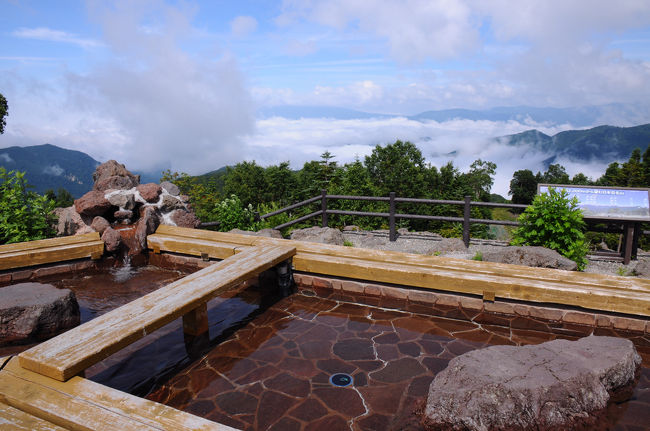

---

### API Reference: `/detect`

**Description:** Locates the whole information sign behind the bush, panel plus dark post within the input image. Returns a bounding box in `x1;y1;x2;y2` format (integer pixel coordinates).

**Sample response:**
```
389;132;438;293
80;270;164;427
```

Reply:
537;184;650;265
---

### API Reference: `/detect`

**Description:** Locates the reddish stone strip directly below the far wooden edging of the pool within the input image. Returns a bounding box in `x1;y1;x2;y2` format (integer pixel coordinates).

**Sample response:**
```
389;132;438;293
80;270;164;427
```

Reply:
294;273;650;340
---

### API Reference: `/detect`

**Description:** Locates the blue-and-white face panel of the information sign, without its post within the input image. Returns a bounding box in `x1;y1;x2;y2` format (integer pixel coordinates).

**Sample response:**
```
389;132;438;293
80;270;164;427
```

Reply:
537;184;650;221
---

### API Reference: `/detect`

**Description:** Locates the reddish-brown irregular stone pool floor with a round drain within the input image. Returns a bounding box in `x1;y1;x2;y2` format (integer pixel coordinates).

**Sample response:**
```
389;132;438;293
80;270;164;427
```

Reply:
147;294;650;431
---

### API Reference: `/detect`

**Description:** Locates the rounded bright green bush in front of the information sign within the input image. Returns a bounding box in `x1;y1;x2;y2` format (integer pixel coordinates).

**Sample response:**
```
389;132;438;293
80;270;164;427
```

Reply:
512;187;589;271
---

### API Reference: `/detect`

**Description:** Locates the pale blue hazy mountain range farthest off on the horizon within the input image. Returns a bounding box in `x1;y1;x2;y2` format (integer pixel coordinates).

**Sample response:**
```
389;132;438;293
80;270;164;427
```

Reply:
257;103;650;127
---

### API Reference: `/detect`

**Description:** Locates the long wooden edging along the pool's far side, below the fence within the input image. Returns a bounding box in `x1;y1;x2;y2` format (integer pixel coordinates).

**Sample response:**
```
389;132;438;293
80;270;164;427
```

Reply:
147;225;650;317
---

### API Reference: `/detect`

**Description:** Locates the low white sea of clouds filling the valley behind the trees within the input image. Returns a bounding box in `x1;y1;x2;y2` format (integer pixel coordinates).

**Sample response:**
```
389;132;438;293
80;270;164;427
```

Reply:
242;117;588;196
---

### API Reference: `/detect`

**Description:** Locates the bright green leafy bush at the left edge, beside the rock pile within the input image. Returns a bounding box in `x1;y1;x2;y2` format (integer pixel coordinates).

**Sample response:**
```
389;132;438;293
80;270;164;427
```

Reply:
0;166;55;244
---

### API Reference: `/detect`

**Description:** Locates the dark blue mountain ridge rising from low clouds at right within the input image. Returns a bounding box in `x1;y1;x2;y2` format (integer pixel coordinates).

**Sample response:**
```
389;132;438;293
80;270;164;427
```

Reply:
495;124;650;163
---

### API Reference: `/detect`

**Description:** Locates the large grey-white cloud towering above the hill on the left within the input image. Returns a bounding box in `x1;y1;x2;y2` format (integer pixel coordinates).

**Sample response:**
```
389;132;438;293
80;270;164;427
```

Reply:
0;1;254;173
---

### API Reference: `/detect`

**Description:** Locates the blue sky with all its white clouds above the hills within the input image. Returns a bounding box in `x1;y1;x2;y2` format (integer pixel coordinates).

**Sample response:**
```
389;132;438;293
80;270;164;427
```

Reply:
0;0;650;194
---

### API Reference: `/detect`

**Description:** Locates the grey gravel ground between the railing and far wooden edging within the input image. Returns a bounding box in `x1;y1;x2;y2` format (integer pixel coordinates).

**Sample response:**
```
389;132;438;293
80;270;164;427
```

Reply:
343;231;650;276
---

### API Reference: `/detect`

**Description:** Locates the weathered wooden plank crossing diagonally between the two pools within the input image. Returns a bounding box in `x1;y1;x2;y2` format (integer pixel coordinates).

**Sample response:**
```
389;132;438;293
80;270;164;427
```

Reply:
18;245;295;381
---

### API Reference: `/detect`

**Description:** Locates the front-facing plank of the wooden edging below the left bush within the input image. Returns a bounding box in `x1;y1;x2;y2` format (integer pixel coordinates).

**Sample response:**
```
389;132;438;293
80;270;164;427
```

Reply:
0;240;104;270
